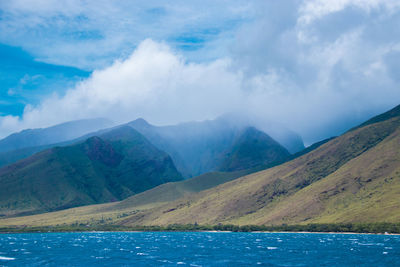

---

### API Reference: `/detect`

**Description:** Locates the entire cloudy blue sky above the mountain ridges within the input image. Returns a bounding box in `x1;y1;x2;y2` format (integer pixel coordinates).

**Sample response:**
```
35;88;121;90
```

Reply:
0;0;400;147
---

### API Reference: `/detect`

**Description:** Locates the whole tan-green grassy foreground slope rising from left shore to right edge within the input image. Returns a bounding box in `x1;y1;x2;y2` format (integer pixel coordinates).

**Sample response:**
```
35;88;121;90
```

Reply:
0;117;400;226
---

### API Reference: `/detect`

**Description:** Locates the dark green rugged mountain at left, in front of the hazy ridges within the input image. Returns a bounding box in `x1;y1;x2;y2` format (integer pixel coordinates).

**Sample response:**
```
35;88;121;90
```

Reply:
0;126;182;218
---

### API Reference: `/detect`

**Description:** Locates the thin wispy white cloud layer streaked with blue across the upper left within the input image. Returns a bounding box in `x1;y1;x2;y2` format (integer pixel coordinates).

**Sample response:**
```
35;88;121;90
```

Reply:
0;0;252;70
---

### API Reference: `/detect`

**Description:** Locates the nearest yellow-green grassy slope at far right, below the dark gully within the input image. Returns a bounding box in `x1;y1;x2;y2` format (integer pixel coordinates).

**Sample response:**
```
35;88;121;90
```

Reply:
236;129;400;224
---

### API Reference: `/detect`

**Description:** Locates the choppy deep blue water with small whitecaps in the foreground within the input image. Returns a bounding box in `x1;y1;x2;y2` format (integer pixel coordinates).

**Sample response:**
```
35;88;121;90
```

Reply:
0;232;400;266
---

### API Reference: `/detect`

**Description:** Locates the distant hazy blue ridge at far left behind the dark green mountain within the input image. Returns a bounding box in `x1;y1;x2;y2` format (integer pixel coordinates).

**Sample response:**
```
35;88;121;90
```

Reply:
0;118;113;152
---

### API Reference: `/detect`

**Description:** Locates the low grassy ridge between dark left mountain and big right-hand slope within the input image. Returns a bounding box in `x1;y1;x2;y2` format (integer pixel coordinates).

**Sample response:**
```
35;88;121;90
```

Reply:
0;171;246;226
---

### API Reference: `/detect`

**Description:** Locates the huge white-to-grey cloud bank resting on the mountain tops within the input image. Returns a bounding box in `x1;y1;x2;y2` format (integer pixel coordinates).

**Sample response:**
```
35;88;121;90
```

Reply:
0;0;400;144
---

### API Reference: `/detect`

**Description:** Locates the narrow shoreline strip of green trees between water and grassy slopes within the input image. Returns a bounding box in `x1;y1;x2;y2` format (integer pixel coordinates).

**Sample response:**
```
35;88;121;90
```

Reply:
0;223;400;235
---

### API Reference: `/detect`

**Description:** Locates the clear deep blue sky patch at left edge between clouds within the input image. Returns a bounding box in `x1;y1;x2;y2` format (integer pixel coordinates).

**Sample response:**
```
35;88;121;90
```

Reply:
0;44;90;116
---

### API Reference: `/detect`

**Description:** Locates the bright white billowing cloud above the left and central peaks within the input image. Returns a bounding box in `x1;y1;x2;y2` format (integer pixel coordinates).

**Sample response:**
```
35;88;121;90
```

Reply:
1;40;243;137
